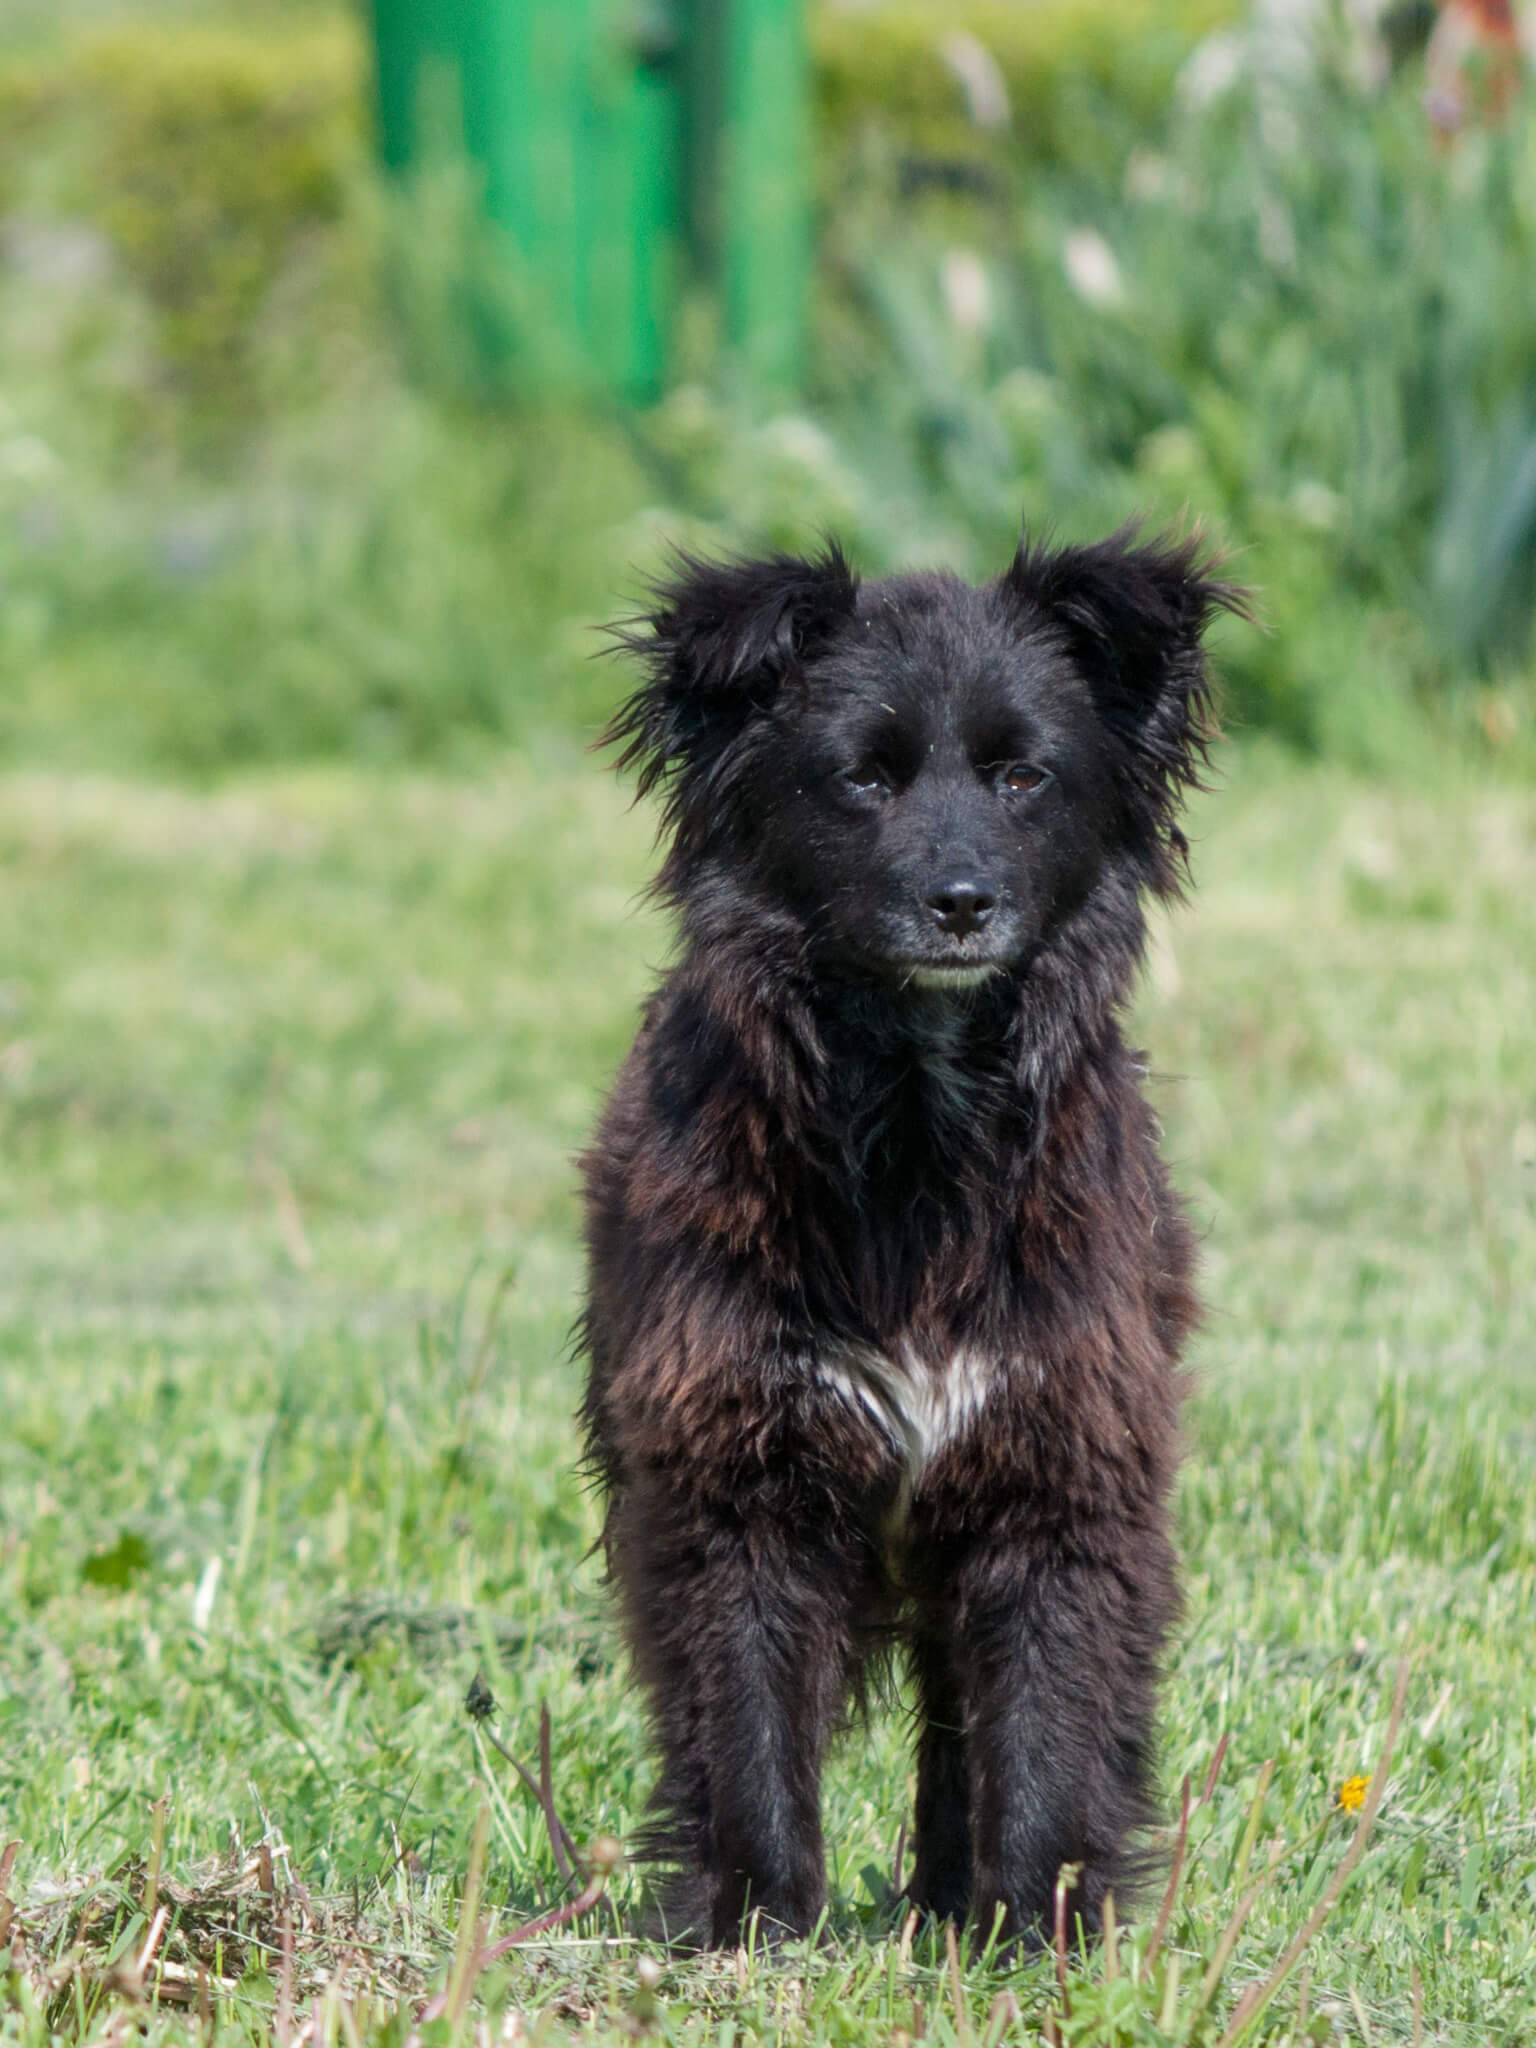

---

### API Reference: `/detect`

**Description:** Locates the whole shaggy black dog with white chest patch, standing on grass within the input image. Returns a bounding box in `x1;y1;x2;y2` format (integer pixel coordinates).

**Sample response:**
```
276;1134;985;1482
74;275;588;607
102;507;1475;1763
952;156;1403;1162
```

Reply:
584;535;1239;1944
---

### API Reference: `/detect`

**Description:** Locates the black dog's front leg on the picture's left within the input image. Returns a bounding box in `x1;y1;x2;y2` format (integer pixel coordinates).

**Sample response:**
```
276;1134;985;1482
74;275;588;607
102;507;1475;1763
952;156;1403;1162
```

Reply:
610;1475;856;1948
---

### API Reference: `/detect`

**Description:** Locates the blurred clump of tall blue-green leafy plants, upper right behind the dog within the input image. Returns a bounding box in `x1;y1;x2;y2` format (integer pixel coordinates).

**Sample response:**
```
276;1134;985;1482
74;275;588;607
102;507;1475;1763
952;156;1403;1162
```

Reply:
821;10;1536;756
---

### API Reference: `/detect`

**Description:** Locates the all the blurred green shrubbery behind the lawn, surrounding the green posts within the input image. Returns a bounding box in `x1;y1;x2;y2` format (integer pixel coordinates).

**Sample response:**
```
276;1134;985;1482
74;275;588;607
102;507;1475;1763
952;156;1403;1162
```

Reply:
0;0;1536;772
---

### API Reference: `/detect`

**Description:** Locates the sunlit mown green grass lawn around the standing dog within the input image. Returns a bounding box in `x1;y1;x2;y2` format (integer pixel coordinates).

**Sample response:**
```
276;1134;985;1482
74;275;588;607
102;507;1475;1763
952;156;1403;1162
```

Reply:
0;741;1536;2048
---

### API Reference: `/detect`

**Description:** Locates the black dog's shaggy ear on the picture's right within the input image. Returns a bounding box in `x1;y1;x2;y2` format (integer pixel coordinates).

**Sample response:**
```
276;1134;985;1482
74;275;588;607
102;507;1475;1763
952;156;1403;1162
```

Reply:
1001;526;1247;893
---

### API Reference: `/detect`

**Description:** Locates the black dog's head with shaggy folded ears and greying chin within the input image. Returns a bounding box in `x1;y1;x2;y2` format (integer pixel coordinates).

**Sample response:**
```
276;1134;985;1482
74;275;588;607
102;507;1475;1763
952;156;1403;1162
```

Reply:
606;532;1241;987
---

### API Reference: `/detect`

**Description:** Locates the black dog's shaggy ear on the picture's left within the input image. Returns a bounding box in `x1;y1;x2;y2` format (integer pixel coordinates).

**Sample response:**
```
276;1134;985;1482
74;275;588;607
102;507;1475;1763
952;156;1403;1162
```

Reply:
600;541;858;797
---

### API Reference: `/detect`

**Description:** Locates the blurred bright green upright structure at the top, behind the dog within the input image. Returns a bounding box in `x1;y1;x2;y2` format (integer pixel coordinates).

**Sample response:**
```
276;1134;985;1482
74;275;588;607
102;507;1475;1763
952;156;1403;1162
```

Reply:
373;0;811;399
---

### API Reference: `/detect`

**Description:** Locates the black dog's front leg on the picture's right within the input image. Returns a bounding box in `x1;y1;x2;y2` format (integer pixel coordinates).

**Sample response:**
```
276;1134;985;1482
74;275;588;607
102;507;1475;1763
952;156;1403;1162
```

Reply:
937;1524;1176;1937
